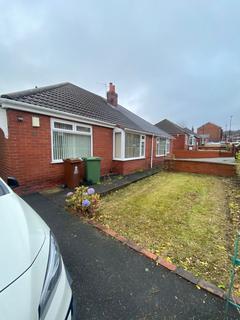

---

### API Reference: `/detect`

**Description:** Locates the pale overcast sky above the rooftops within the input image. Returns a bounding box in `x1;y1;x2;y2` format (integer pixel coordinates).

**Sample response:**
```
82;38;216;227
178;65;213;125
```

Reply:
0;0;240;129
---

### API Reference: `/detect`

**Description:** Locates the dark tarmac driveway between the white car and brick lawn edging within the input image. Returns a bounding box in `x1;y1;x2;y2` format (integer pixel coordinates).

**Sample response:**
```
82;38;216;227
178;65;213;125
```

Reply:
24;193;239;320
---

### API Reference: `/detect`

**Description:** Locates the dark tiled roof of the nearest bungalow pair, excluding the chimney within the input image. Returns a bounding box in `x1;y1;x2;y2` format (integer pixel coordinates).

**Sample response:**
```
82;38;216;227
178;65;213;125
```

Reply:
1;82;169;137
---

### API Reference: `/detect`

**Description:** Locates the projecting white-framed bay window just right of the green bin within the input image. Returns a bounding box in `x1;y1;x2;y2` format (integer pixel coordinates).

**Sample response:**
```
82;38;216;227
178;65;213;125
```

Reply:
113;128;146;160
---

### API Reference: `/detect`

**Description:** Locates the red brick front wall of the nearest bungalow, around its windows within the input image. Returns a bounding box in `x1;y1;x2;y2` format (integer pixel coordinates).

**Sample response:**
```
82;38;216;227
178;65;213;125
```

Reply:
0;110;170;187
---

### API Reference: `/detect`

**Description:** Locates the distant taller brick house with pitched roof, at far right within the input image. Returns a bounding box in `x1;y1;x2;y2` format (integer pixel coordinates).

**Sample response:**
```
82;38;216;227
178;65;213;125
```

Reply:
197;122;223;144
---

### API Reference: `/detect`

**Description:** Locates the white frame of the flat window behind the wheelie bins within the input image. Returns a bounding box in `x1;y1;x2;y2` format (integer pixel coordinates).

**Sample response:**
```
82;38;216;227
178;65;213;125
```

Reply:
50;118;93;163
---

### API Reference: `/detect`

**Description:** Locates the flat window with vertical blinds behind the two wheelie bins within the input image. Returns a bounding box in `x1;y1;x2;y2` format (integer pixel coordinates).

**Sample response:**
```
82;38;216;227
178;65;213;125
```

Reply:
51;119;92;162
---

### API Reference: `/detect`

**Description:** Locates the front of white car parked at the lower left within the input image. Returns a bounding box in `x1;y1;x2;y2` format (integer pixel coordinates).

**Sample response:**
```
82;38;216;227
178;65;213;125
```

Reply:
0;178;74;320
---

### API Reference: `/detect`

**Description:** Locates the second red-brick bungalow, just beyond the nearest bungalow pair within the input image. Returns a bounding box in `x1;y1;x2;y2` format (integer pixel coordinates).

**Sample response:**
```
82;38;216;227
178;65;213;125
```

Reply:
155;119;199;153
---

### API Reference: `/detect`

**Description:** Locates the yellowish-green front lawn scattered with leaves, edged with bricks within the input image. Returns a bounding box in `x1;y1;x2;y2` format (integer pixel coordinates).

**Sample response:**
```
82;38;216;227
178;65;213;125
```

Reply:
95;172;239;288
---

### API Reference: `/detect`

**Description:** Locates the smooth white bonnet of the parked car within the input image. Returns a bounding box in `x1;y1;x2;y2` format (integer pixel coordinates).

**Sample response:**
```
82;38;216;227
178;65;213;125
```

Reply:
0;192;46;292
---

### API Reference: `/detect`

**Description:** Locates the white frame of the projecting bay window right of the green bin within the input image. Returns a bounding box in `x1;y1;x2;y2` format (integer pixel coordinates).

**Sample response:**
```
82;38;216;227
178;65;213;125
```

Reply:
113;128;146;161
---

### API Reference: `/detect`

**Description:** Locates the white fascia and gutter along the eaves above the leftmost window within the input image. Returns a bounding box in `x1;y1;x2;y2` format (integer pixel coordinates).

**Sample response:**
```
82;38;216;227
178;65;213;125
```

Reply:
0;98;116;128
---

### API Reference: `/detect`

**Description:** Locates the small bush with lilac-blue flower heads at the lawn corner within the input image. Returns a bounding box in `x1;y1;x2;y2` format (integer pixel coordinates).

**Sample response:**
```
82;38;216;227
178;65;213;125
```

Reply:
66;186;100;217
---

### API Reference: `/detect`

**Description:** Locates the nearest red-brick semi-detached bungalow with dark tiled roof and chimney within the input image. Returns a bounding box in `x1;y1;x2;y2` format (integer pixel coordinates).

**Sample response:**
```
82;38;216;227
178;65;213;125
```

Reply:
0;83;172;190
